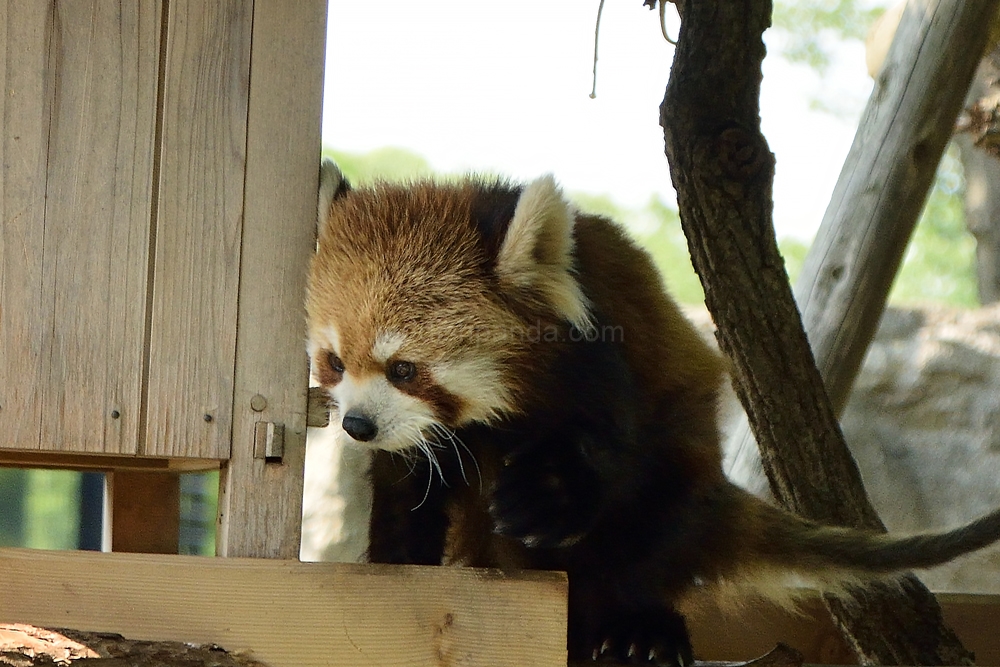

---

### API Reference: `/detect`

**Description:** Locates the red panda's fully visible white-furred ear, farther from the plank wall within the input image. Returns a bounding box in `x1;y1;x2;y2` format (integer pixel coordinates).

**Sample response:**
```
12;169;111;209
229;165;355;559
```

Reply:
496;176;592;331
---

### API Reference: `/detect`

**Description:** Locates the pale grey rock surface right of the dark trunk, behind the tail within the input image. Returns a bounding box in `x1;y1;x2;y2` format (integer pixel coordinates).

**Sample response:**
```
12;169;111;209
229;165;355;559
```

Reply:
841;306;1000;593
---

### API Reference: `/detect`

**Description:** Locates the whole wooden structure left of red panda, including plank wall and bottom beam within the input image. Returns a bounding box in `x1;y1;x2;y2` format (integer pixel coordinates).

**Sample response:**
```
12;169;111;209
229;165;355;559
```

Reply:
0;0;566;666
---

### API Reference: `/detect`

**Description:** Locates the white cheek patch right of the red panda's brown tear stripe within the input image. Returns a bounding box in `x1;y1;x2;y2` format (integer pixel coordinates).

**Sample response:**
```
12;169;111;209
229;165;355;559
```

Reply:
430;357;511;424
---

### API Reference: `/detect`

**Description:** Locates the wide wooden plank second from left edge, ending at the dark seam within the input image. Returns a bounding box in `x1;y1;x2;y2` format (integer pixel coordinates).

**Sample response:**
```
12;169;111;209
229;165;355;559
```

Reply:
41;0;161;454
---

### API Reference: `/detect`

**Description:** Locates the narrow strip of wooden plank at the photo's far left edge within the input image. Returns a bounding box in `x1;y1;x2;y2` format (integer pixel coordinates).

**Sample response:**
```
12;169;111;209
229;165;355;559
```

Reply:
0;0;50;449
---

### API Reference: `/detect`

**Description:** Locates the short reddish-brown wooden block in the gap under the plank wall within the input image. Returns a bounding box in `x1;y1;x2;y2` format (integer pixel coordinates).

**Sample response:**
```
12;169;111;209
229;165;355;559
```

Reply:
108;470;181;554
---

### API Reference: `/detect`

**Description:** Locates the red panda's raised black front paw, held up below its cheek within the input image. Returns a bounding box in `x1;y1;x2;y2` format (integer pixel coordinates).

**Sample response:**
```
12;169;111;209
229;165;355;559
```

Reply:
490;442;600;549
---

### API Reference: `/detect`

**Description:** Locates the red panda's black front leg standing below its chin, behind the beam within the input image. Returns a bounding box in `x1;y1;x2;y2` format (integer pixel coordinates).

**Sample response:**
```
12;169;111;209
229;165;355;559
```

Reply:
368;451;448;565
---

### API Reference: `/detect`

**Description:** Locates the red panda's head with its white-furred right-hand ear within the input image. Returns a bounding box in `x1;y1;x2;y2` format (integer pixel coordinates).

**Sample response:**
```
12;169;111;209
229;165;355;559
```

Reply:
307;172;587;451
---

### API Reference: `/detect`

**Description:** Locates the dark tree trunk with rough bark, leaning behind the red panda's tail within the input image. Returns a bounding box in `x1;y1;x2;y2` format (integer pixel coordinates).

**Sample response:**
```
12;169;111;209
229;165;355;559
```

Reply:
661;0;985;665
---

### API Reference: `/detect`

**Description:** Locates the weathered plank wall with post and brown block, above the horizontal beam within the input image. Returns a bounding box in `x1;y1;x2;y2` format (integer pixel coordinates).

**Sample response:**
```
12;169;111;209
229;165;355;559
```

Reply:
0;0;326;558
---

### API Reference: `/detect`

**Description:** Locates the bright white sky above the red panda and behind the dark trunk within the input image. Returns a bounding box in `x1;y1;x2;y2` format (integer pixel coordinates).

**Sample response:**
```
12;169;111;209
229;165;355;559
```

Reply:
323;0;871;240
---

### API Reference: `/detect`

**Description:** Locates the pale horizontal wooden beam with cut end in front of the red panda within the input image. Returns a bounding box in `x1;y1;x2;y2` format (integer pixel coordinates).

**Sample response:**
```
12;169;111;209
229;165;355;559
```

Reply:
0;549;567;667
